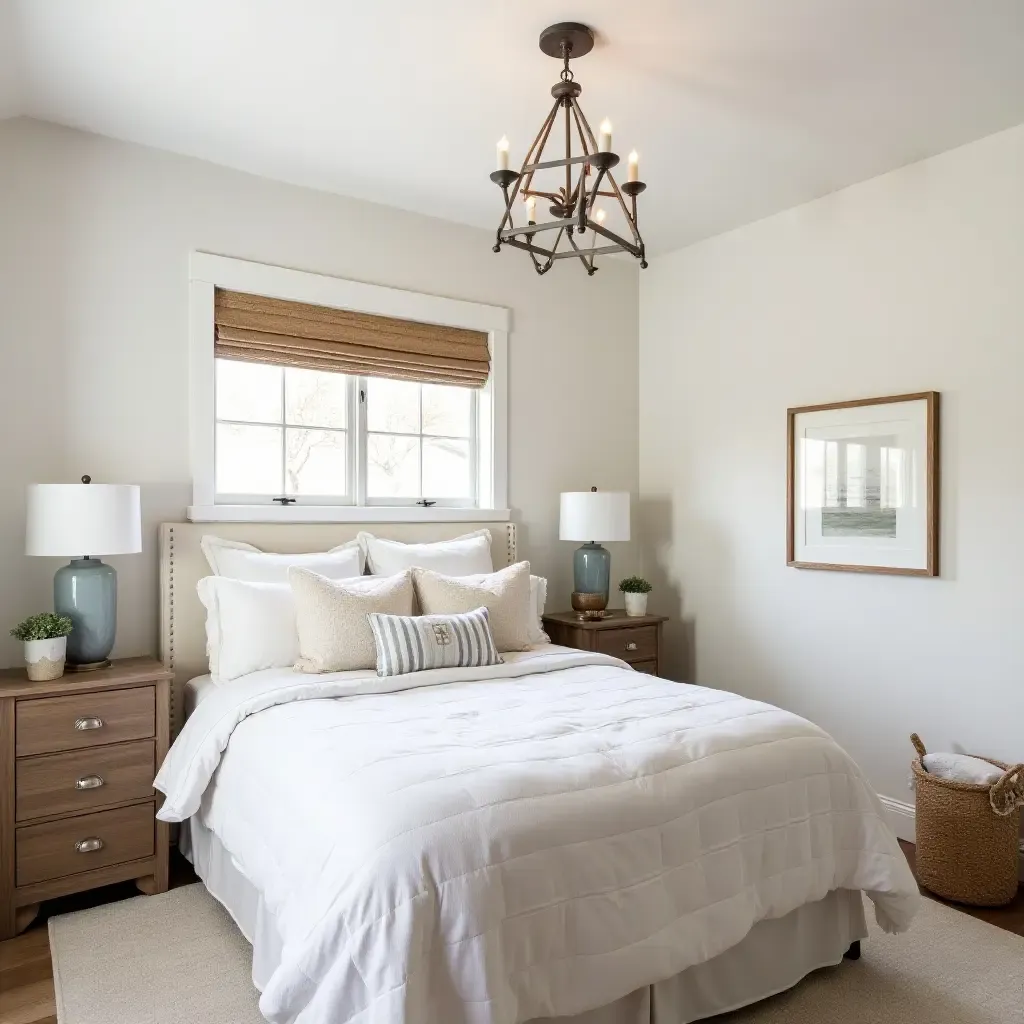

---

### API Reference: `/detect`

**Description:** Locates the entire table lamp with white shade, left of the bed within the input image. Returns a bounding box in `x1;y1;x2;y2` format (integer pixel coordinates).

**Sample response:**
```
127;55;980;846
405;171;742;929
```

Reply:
25;476;142;672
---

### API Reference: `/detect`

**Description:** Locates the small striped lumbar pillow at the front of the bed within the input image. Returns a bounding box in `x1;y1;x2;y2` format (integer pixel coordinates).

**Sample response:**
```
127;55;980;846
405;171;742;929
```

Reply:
367;608;502;676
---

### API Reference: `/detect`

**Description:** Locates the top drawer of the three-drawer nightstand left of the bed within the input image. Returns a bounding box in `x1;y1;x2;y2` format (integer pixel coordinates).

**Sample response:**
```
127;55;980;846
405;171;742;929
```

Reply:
14;686;157;758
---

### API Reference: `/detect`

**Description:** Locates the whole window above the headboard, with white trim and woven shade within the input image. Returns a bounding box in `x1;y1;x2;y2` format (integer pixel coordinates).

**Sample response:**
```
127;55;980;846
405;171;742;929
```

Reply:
188;253;509;522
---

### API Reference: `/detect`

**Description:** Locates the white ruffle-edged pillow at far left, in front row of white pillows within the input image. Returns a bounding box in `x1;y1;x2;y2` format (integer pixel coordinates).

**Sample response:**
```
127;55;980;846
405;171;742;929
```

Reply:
196;577;299;683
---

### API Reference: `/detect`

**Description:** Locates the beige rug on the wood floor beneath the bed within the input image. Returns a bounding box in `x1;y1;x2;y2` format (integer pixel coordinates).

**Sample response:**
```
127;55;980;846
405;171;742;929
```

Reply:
49;885;1024;1024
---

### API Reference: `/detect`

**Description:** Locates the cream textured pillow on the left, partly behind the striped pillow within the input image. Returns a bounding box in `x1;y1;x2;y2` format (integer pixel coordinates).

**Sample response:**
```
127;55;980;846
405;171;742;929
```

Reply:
288;566;413;672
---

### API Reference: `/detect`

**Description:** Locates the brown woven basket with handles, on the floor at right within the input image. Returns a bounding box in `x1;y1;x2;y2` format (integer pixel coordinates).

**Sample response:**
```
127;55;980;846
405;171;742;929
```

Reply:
910;733;1024;906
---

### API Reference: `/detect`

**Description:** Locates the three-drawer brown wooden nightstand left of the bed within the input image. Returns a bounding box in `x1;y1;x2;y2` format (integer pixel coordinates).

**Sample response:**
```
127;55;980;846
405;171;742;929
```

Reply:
0;657;171;939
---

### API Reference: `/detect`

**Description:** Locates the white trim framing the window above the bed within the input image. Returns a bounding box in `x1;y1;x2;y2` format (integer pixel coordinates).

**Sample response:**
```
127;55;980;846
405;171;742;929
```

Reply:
187;252;510;522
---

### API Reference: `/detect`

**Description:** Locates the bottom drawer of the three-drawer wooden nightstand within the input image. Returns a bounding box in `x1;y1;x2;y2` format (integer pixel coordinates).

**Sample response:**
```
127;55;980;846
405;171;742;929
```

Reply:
14;801;156;886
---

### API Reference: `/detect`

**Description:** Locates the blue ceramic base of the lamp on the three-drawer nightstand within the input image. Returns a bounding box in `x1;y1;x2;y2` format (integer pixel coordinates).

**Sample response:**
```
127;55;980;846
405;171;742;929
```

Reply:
53;558;118;672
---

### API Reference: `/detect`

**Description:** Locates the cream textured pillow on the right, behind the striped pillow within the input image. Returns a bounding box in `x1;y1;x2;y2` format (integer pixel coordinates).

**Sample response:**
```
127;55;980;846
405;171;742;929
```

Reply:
413;562;534;651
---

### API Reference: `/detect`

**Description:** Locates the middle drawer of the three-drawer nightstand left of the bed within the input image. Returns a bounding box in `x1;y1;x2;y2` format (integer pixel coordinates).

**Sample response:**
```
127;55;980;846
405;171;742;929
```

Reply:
14;739;156;821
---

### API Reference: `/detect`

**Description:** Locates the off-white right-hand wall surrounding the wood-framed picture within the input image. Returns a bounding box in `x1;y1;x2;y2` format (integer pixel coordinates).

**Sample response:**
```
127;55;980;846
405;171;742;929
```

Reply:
640;126;1024;801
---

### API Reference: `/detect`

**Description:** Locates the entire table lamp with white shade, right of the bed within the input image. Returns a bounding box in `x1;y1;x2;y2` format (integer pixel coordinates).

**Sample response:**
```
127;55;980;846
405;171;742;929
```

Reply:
558;487;630;618
